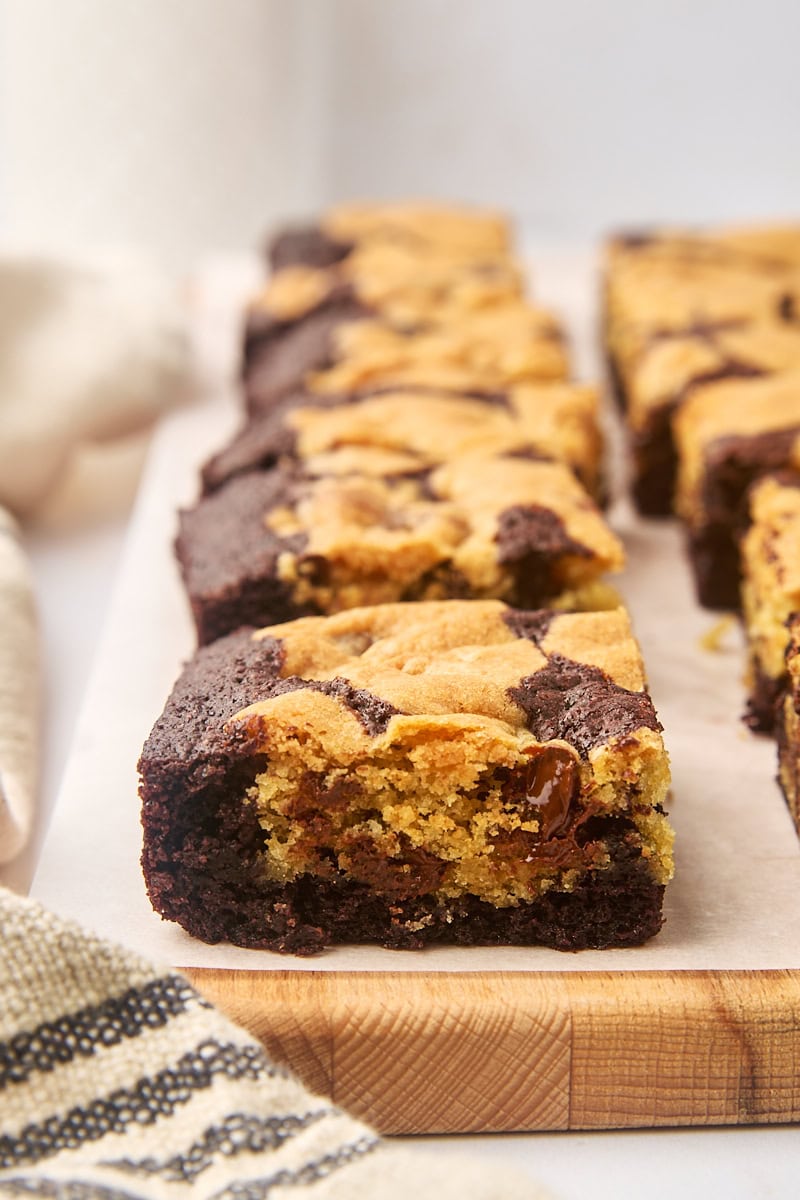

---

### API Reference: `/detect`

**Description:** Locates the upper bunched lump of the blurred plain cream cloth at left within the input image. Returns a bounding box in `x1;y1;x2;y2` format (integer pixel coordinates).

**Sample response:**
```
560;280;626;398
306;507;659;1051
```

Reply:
0;258;188;516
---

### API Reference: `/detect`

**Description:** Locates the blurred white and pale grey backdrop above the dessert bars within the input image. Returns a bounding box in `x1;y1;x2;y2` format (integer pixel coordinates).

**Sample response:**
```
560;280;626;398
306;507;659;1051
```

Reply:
0;0;800;263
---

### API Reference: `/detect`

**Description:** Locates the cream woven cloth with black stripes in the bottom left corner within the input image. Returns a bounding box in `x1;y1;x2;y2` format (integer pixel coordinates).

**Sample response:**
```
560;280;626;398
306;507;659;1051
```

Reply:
0;889;551;1200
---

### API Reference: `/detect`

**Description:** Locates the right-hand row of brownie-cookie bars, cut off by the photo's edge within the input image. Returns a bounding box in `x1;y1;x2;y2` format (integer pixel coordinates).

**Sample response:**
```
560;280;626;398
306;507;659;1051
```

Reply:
606;226;800;835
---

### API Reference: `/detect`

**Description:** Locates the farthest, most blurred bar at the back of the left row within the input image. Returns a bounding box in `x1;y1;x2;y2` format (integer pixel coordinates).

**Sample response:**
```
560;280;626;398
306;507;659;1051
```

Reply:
269;203;511;270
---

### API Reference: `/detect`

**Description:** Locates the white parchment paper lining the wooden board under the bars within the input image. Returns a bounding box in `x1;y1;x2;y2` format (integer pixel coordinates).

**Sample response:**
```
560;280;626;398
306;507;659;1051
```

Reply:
32;250;800;971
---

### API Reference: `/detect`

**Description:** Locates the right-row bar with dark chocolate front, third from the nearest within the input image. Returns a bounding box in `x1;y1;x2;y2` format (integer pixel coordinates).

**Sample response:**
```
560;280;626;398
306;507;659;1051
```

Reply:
673;371;800;608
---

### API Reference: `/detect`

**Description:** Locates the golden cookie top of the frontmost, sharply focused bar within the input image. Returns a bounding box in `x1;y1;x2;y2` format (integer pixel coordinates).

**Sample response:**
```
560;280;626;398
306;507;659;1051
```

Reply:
231;600;658;756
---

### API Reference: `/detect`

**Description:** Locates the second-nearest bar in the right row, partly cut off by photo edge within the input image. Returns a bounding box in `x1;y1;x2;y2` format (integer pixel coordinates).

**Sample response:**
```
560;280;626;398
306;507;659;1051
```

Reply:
741;475;800;733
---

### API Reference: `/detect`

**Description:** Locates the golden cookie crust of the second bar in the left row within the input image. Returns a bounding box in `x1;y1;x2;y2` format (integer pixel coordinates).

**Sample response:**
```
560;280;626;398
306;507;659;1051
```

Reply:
264;446;624;612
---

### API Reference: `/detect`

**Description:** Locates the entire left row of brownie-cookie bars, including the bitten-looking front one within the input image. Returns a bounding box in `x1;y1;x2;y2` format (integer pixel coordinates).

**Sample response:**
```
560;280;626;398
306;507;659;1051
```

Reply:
140;205;672;953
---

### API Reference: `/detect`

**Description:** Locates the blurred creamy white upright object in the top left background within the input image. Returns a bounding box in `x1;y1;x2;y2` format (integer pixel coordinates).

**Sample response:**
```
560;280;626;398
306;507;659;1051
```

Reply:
0;0;326;266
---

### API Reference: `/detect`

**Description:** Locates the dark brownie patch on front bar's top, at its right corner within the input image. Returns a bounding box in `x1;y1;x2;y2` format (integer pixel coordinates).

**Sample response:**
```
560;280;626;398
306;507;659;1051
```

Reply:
509;654;661;758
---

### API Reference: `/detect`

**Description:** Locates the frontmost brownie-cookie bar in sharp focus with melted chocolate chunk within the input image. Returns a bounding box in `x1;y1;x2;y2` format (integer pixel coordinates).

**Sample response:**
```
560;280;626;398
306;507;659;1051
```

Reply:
139;601;673;954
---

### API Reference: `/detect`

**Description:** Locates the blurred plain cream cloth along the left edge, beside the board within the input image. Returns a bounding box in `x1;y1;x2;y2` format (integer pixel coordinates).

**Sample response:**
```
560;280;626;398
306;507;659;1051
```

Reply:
0;258;188;863
